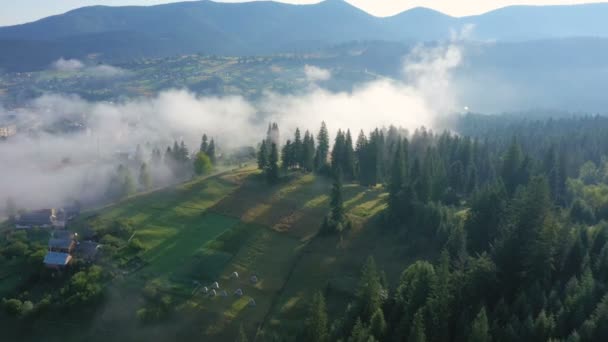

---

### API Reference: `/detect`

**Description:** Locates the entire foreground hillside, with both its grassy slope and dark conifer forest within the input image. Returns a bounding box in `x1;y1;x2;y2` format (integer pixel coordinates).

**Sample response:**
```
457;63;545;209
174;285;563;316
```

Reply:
0;113;608;341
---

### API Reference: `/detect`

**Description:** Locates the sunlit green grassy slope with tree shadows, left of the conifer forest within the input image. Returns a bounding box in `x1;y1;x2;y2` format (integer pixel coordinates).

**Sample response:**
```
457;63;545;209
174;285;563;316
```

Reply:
3;169;432;341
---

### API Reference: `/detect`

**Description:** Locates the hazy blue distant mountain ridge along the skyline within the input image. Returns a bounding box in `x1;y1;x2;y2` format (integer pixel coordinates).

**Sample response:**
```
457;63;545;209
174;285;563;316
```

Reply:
0;0;608;70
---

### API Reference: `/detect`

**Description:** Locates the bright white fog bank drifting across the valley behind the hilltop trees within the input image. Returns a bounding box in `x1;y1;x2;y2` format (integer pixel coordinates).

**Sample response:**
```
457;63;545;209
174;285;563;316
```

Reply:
0;40;462;208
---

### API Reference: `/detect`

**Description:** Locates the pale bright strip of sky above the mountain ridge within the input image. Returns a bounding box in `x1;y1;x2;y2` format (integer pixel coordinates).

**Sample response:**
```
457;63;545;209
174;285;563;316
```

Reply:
0;0;607;26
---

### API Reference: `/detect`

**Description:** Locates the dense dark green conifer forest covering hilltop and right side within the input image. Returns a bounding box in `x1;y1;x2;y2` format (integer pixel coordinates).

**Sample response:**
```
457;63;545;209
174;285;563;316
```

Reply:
258;114;608;342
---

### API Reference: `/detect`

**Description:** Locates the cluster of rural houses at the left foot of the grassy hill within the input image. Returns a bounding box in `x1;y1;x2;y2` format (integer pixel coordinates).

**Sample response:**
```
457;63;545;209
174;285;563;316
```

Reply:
15;206;99;269
